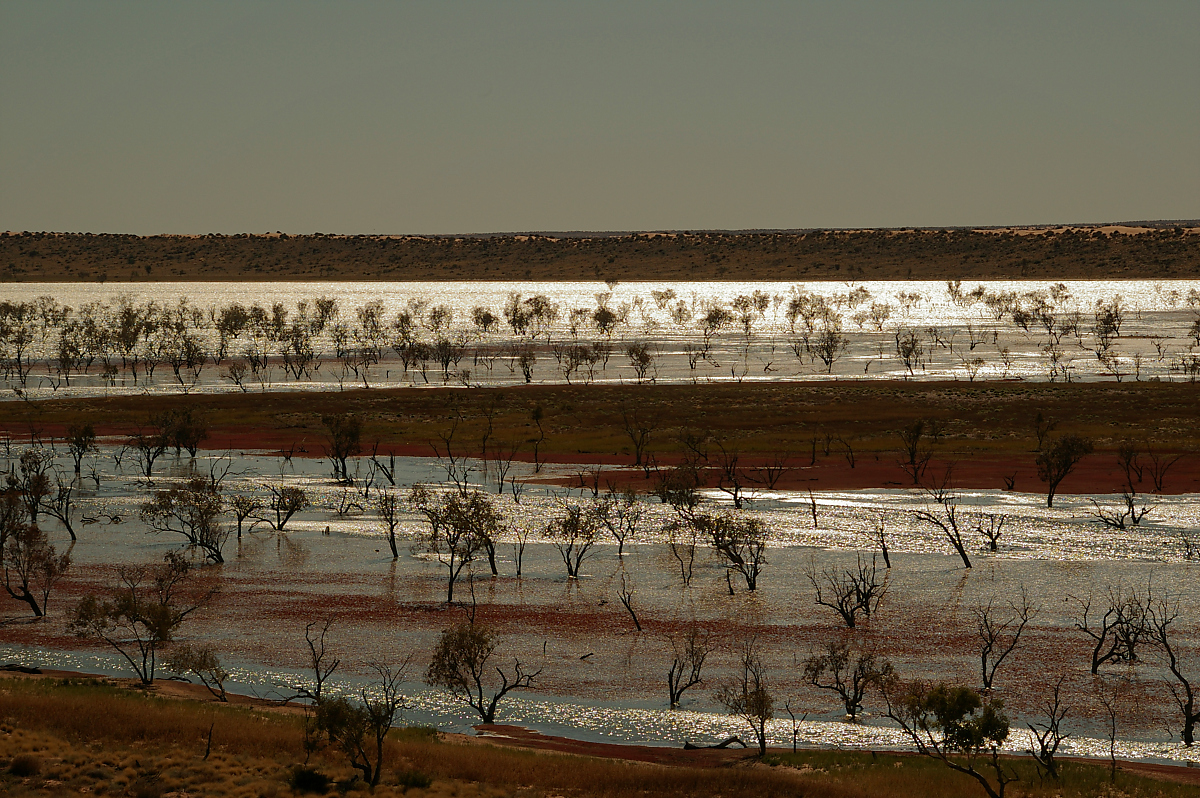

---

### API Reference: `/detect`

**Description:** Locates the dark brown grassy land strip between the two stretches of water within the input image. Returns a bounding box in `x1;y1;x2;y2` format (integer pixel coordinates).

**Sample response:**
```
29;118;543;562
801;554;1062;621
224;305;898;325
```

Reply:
0;382;1200;463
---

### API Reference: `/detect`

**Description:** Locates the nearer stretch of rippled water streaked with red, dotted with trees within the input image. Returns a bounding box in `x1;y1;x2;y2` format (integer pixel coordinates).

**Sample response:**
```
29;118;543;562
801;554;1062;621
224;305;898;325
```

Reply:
0;449;1200;761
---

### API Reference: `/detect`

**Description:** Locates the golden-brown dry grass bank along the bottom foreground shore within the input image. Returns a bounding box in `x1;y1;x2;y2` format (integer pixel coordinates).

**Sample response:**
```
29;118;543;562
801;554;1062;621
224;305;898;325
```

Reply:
0;679;1200;798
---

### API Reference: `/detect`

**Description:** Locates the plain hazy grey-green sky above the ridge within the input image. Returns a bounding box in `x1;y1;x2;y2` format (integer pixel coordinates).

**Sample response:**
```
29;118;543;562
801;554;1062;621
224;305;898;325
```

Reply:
0;0;1200;233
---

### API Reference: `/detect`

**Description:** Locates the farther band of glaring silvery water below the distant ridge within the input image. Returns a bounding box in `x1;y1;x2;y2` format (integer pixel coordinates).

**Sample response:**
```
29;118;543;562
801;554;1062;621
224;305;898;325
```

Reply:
9;281;1200;396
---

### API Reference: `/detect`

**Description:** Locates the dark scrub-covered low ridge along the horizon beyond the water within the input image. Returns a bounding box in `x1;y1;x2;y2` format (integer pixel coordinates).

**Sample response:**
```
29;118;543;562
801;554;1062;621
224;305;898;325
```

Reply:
0;227;1200;282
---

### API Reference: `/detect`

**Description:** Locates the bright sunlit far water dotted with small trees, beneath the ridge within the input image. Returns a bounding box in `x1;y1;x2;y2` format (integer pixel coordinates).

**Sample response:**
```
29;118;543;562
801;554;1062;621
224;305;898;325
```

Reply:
0;281;1200;396
